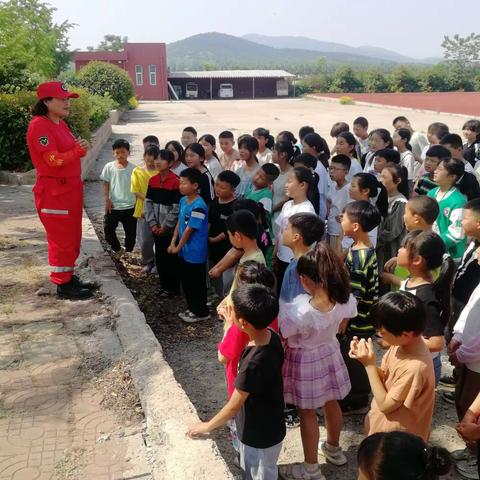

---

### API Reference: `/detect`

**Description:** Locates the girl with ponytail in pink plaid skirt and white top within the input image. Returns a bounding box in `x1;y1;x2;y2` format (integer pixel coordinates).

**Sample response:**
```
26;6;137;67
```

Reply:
279;242;357;480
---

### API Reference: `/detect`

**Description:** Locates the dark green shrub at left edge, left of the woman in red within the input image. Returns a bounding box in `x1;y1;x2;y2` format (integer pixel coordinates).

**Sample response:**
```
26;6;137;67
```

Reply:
0;92;37;171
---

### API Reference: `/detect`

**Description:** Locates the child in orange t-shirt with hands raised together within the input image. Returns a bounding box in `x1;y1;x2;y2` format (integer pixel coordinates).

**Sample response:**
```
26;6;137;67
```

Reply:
350;292;435;442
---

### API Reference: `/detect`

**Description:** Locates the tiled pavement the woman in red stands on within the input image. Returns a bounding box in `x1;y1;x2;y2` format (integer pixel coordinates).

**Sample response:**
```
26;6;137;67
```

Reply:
0;187;150;480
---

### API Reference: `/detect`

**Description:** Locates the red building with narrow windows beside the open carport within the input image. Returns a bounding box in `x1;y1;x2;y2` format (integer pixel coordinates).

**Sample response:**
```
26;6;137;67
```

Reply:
73;43;168;100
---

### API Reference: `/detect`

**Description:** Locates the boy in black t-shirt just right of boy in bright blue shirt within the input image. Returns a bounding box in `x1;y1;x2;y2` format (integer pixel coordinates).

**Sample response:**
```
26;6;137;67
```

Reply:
208;170;240;298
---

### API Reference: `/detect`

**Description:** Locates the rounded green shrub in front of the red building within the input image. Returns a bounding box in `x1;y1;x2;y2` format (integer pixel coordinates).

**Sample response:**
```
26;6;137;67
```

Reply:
78;62;135;107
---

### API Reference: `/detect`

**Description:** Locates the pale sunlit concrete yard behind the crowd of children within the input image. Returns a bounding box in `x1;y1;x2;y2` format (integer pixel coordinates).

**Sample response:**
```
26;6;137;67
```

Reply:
110;98;465;154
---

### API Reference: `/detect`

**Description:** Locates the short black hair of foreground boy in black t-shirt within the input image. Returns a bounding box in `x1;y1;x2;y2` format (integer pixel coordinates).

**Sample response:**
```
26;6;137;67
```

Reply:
232;283;278;330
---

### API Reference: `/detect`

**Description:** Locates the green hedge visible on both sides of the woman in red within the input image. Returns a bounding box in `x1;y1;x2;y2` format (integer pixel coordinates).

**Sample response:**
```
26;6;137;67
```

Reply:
0;87;118;171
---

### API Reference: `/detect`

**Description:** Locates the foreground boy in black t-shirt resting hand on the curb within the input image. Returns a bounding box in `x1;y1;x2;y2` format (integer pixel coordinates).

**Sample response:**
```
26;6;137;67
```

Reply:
188;284;285;480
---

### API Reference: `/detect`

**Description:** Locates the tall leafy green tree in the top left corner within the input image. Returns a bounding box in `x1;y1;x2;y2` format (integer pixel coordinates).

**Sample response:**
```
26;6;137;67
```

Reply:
0;0;74;77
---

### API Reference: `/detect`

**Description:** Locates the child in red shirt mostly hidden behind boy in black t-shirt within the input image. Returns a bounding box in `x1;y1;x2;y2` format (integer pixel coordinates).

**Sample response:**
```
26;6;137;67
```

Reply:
218;260;278;398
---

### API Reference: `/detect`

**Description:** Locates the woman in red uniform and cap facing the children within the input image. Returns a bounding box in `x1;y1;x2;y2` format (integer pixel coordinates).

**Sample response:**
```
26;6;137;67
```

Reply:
27;82;93;300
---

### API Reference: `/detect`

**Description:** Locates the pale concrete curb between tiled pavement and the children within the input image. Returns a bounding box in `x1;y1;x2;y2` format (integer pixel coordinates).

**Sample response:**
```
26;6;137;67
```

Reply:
82;213;233;480
